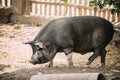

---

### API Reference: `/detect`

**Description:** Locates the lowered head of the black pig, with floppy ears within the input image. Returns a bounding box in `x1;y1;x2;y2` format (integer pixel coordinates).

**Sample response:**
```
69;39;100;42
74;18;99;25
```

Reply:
25;41;57;64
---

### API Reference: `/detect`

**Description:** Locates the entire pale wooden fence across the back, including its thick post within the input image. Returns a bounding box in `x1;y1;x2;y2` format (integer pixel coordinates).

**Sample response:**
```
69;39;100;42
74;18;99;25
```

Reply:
0;0;120;22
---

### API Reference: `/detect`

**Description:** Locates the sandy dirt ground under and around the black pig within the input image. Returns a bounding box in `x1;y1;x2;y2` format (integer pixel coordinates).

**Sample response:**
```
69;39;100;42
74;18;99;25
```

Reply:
0;23;120;80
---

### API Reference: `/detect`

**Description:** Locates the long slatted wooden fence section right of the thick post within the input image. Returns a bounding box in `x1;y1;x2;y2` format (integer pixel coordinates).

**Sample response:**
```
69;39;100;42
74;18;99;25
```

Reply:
29;0;118;22
